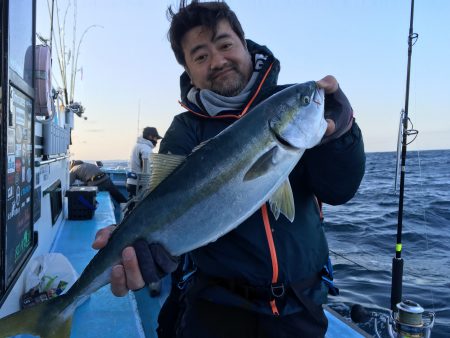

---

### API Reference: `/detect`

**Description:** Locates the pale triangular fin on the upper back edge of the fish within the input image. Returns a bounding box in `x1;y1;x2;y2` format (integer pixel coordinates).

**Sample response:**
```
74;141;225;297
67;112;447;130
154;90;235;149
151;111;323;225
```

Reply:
149;153;186;191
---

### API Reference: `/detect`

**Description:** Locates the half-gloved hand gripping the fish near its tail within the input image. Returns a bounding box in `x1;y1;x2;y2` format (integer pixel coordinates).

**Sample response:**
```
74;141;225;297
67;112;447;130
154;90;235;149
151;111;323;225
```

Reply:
92;225;178;297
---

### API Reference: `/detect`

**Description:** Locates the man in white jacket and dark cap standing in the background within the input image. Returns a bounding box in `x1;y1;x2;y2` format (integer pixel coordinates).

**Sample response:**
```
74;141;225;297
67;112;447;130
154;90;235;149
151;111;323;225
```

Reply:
127;127;162;198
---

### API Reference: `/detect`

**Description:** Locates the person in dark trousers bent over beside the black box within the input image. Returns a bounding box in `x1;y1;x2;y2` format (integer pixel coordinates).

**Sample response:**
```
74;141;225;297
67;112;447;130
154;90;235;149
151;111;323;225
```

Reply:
69;160;127;205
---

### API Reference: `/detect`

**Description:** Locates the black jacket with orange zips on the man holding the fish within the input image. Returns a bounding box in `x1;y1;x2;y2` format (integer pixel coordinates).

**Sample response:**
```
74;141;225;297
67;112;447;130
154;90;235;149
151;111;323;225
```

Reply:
160;40;365;314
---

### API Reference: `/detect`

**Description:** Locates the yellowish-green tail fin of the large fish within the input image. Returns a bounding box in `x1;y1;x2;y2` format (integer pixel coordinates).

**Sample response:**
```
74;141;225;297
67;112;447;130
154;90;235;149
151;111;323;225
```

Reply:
0;295;76;338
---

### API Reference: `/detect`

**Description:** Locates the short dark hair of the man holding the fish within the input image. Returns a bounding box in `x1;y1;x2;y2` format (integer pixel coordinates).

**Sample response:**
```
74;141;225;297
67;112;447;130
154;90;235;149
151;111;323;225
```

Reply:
167;0;246;66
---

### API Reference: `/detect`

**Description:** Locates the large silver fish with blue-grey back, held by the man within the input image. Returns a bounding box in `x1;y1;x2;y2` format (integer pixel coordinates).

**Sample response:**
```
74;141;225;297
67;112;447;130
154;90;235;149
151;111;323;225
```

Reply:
0;82;327;338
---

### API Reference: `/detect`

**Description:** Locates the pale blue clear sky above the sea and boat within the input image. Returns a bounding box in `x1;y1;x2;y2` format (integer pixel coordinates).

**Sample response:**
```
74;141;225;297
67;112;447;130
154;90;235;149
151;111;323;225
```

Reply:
37;0;450;160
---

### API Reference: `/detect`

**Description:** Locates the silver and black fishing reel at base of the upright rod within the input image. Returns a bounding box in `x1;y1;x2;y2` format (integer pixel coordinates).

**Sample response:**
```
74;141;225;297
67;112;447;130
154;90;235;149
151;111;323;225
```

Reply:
351;300;435;338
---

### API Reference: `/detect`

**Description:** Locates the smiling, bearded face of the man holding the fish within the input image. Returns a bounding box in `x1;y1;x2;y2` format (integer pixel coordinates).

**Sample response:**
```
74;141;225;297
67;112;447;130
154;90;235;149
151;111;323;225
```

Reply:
181;20;253;96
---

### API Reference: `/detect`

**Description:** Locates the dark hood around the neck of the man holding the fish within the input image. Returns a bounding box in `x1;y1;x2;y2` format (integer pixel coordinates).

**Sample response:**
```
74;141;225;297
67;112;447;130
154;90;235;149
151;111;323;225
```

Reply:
180;39;280;116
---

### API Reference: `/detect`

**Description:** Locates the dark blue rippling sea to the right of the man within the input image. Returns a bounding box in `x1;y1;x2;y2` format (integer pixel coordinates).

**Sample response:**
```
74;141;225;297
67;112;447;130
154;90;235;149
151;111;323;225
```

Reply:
324;150;450;338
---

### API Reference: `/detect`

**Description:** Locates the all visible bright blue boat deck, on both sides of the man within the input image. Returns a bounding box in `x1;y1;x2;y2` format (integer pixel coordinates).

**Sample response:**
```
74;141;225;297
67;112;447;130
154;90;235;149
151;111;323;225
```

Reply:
17;192;367;338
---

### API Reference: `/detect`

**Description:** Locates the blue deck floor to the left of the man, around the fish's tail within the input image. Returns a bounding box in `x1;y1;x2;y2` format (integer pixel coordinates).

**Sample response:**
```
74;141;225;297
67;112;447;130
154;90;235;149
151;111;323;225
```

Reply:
53;192;144;338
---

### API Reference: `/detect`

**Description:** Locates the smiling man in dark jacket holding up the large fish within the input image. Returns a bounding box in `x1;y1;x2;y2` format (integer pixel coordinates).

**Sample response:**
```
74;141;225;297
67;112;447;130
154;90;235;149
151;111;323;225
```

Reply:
93;1;365;338
